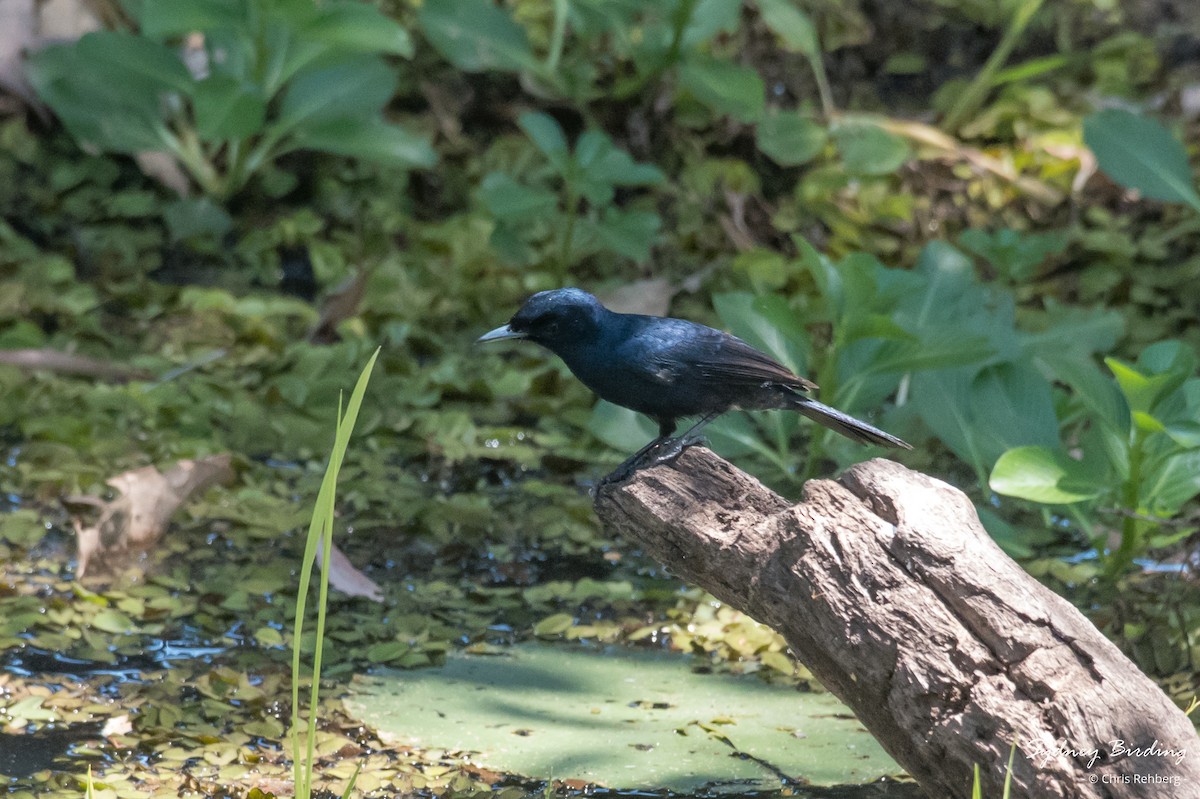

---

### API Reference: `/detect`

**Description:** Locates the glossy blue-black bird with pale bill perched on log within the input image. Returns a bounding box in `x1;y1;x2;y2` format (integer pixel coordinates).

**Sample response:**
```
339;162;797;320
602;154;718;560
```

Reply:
476;288;912;482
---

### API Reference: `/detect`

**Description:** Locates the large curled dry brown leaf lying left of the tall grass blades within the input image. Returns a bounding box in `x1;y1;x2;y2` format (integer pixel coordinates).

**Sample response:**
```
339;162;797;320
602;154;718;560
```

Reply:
62;455;234;577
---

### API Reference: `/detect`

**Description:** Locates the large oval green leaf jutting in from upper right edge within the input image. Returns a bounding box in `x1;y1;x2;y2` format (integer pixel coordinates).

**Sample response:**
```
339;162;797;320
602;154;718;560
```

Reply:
1084;108;1200;211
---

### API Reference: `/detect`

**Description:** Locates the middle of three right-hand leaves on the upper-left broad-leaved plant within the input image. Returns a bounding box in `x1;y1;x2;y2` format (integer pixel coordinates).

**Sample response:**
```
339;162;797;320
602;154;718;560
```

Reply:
272;55;396;136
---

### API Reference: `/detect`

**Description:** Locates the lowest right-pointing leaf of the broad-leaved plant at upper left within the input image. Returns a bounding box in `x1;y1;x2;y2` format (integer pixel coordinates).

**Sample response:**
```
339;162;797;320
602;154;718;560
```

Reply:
285;116;438;169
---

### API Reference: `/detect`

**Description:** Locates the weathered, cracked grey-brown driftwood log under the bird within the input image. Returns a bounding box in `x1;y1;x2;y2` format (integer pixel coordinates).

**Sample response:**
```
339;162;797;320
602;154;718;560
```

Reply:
596;447;1200;799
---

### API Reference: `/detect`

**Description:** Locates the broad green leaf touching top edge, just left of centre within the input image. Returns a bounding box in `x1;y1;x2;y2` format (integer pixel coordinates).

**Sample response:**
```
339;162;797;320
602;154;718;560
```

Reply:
418;0;539;72
